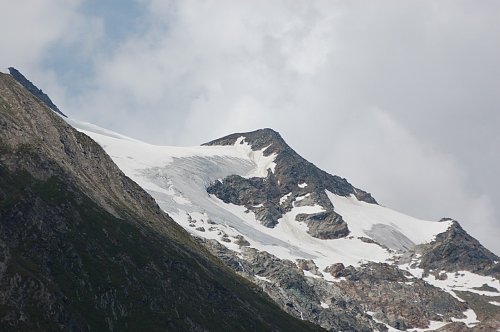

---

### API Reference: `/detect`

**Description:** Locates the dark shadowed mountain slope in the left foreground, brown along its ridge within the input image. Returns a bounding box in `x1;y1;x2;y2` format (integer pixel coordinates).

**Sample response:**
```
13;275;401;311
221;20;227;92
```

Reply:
0;73;321;331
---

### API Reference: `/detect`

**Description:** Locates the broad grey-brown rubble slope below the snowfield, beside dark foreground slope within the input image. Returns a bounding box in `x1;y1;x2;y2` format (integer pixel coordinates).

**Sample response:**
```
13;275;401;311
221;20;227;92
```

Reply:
200;236;480;331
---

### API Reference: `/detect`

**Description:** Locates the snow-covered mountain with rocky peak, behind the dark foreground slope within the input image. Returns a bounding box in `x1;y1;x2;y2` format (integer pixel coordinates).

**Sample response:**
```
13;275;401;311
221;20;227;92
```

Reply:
67;119;500;331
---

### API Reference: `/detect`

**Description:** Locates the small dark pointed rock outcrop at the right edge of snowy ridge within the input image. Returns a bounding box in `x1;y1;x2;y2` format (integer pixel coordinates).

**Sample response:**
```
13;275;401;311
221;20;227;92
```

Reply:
420;221;500;279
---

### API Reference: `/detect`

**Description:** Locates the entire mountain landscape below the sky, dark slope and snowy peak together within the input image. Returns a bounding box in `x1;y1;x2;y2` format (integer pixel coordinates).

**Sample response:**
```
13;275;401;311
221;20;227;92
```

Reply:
0;68;500;331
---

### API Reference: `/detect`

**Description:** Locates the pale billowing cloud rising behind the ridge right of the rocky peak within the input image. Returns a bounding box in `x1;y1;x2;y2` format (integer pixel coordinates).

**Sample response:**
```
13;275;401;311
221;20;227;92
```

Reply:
324;109;500;252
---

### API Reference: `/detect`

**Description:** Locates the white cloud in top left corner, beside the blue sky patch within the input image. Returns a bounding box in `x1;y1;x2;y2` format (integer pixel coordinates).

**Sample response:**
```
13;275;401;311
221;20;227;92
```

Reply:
0;0;103;115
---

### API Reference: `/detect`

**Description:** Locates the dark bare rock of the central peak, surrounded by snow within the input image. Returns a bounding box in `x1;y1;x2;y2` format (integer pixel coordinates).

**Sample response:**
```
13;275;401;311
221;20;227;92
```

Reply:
204;129;377;239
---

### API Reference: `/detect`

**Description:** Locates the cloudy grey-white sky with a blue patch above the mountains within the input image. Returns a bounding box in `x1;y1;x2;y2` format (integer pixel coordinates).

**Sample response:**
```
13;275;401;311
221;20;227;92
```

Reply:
0;0;500;254
